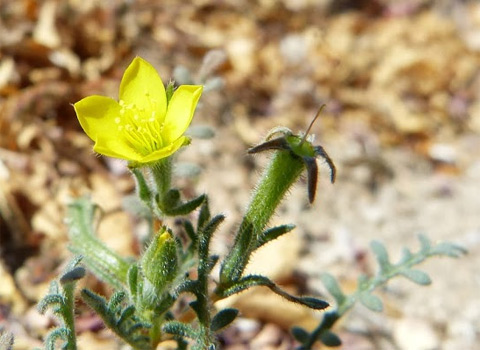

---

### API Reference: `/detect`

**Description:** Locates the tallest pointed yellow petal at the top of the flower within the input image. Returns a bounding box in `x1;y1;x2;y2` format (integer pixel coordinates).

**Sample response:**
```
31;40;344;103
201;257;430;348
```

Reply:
119;57;167;122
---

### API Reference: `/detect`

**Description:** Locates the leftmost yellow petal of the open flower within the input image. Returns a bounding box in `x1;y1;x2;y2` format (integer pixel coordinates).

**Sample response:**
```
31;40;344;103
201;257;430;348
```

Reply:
73;95;120;141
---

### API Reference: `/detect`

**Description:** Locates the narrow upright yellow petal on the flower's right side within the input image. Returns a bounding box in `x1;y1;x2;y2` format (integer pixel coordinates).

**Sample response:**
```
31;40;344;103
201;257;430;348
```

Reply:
162;85;203;143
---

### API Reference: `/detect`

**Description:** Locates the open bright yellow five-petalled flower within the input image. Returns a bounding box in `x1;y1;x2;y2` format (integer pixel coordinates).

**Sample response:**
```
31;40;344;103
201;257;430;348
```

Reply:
73;57;202;165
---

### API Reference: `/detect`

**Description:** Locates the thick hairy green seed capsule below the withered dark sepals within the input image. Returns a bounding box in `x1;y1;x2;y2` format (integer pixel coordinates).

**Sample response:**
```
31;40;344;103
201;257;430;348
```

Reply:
220;150;305;285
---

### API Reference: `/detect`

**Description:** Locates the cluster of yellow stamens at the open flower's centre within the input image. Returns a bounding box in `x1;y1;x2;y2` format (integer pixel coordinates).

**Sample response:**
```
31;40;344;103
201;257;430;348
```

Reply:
115;100;163;156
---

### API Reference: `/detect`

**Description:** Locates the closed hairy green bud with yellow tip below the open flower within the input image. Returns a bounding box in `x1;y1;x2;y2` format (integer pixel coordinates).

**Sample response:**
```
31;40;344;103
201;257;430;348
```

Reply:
141;228;178;293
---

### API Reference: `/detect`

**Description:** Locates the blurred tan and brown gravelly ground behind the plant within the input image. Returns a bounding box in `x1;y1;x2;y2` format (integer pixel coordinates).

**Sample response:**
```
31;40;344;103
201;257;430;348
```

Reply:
0;0;480;350
